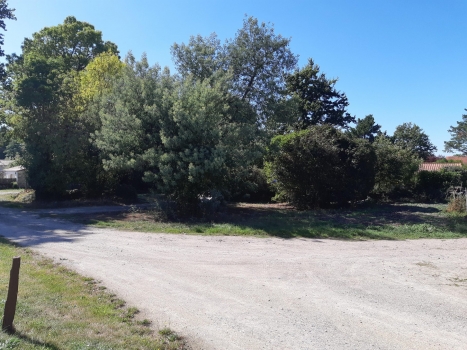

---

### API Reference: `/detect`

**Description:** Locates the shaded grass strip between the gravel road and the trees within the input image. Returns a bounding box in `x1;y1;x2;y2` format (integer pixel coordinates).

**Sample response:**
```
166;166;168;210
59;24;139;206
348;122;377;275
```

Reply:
62;203;467;240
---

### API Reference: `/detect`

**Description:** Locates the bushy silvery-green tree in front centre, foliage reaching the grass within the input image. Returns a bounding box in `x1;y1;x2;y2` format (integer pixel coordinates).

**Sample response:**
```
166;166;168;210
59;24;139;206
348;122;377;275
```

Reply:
96;58;261;211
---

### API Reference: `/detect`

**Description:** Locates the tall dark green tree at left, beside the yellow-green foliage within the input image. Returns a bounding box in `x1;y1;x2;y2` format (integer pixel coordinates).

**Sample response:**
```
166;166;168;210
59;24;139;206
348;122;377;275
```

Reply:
5;17;118;198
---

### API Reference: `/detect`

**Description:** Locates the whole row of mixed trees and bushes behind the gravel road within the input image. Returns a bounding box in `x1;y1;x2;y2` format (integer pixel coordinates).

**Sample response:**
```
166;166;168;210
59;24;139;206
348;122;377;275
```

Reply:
0;10;467;210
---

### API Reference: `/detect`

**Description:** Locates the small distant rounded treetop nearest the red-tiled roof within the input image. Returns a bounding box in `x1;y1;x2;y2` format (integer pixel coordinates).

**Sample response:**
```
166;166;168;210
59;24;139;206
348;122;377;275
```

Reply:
392;123;437;159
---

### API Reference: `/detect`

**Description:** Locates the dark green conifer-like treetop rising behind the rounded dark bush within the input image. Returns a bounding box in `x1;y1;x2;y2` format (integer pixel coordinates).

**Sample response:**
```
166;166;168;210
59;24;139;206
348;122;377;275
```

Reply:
286;58;355;129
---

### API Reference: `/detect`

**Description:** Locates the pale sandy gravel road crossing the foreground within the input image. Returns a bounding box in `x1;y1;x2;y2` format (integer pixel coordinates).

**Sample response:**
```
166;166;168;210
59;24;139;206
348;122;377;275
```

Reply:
0;208;467;349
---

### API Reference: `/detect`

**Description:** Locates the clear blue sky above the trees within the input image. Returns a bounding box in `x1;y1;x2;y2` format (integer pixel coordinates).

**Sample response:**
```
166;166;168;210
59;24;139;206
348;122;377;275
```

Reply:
4;0;467;153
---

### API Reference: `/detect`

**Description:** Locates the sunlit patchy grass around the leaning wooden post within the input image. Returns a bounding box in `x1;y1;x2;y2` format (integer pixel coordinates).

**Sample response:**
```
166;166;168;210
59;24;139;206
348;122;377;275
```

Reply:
0;238;184;350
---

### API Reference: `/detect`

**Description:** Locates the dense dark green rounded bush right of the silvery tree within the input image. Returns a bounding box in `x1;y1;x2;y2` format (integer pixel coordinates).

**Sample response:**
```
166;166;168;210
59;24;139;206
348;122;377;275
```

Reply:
267;125;376;208
